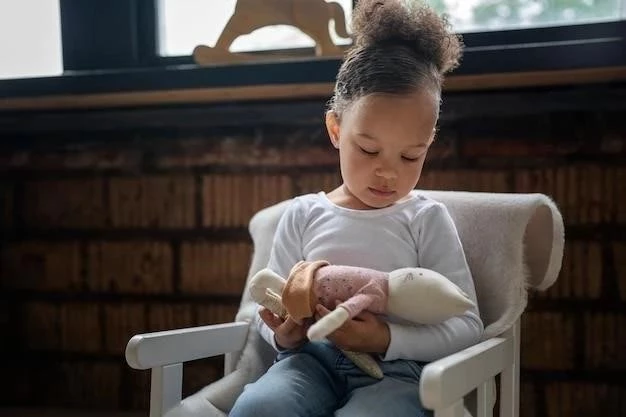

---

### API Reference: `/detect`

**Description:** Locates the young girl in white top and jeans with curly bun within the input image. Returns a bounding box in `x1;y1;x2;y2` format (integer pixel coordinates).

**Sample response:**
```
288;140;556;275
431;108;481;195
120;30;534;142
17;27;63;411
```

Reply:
230;0;483;417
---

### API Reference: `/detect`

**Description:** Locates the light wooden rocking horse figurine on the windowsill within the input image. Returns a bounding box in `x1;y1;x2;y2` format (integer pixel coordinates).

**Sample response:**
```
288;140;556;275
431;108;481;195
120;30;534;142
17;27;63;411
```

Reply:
193;0;350;65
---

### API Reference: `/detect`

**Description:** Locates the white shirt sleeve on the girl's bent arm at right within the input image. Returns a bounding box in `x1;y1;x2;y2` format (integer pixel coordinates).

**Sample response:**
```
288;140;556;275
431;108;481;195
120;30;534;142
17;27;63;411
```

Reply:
383;202;483;362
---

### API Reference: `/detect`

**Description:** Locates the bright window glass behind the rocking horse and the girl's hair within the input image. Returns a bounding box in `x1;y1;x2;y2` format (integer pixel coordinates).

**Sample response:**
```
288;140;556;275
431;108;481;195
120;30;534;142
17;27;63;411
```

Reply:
158;0;626;56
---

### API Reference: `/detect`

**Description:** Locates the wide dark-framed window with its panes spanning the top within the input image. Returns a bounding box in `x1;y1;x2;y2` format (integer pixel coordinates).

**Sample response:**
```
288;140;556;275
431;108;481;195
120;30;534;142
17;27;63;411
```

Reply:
0;0;626;97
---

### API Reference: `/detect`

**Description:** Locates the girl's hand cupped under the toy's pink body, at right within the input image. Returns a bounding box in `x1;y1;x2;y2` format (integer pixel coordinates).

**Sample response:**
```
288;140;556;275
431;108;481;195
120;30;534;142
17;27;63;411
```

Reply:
315;304;390;354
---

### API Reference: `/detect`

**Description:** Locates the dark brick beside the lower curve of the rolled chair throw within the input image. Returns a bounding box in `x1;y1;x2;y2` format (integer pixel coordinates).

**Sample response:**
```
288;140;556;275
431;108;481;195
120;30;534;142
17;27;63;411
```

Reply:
538;240;603;299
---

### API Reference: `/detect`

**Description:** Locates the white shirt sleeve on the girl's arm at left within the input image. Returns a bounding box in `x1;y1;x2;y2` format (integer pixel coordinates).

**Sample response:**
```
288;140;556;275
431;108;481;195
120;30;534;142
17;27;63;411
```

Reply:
253;198;306;351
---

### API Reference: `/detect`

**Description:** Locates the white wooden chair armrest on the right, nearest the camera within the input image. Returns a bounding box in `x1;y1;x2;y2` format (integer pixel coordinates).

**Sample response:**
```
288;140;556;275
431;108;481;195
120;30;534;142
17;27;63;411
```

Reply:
419;337;514;410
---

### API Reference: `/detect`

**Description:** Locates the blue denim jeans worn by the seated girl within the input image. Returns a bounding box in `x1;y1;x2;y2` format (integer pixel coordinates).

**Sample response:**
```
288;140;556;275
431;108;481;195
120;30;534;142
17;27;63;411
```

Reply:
229;341;433;417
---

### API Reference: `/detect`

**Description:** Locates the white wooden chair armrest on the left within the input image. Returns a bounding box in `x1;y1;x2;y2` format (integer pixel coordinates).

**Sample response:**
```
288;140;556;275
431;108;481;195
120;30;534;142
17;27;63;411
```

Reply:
126;322;250;369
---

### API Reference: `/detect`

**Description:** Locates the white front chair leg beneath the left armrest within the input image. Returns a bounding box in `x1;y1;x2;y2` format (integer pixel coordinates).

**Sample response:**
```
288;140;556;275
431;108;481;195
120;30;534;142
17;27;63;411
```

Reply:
150;363;183;417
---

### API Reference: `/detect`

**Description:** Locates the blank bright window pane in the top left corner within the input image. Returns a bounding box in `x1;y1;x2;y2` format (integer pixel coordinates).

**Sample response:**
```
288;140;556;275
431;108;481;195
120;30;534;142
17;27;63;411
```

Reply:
0;0;63;79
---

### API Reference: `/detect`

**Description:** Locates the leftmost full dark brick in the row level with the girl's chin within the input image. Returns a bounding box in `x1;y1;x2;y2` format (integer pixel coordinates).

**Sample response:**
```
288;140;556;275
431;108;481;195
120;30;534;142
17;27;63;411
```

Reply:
23;179;107;228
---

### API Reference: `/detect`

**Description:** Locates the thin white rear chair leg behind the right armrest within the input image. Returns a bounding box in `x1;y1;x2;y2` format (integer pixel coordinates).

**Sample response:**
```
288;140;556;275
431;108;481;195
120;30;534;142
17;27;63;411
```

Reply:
500;319;520;417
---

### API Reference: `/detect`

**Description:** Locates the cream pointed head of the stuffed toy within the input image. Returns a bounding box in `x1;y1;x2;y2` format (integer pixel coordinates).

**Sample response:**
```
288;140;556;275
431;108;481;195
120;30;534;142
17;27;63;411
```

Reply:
387;268;475;324
